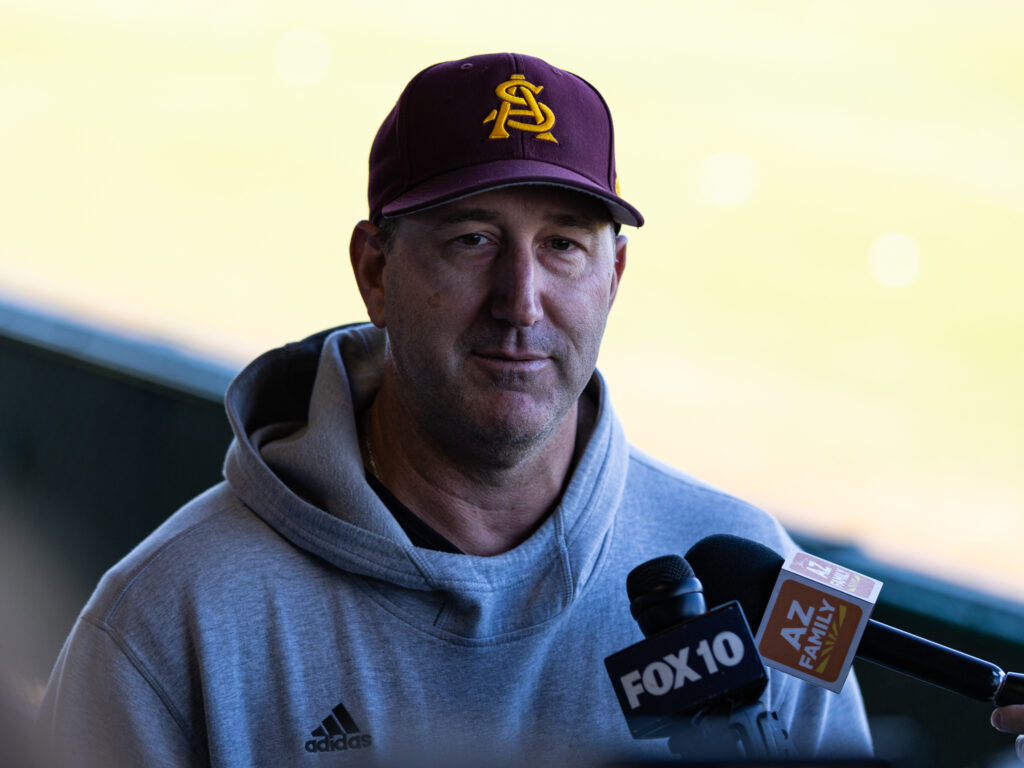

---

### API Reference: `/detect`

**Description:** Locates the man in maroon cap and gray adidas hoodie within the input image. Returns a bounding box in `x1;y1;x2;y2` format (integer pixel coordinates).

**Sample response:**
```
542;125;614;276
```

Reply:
40;54;870;766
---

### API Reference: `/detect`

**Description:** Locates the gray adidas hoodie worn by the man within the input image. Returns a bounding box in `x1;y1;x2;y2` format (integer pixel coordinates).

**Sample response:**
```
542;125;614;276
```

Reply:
39;326;870;768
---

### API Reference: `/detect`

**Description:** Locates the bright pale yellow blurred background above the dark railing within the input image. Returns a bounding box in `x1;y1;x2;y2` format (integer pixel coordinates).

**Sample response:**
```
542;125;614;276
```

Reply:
0;0;1024;765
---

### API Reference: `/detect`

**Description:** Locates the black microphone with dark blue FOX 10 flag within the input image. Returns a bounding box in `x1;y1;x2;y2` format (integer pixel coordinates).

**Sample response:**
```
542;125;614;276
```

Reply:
604;555;791;759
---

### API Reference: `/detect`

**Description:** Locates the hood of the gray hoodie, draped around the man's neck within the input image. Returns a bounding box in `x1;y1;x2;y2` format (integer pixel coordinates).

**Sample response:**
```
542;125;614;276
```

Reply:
224;325;629;643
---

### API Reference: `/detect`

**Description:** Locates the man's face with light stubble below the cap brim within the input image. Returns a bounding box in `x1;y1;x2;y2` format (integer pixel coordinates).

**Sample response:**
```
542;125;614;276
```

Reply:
374;186;626;463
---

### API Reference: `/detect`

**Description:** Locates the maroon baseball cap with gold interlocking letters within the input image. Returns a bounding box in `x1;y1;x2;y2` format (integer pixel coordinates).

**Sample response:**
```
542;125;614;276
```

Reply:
369;53;643;226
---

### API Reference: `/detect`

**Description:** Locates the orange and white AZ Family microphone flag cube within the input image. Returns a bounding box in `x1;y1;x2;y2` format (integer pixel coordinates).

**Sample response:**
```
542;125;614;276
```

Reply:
755;552;882;693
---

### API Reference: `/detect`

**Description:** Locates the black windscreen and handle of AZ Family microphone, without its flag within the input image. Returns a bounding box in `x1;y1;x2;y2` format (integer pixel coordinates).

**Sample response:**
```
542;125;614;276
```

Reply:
686;534;1024;707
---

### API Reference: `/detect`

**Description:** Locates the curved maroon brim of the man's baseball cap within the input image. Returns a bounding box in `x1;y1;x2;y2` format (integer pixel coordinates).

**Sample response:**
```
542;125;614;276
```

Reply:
381;159;643;226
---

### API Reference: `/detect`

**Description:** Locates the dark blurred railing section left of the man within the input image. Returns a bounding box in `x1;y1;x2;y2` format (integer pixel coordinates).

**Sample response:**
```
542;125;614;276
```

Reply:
0;304;233;679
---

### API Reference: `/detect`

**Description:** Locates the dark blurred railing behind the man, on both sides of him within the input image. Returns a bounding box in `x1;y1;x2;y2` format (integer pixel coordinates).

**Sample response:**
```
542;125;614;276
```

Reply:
0;302;1024;768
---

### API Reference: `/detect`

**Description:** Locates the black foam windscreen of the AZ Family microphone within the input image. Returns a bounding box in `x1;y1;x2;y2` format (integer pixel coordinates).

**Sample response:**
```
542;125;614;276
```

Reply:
686;534;785;627
